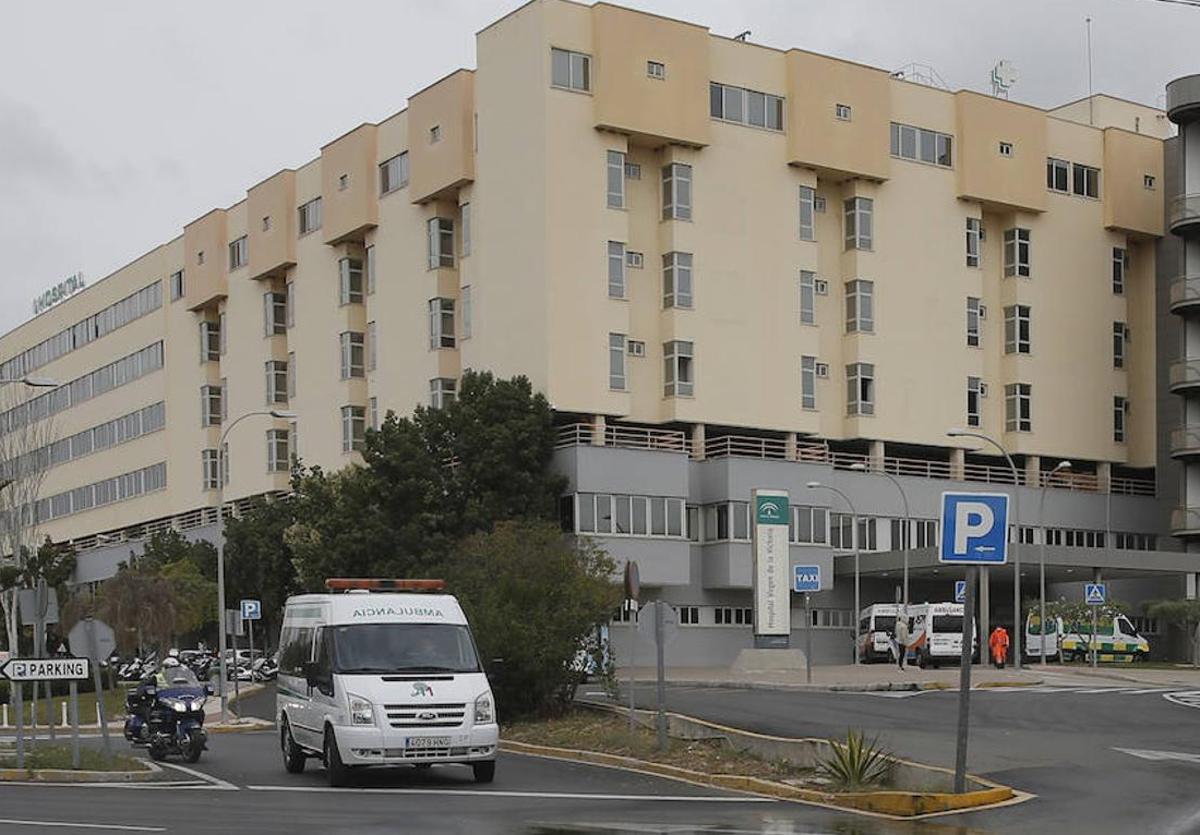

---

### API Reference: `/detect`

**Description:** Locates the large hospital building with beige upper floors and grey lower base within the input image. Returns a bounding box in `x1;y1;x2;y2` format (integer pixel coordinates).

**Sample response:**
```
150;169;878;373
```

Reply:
0;0;1200;661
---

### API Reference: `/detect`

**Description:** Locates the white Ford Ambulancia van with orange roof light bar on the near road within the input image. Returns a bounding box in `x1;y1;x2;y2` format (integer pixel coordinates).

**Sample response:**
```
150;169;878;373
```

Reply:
276;579;499;786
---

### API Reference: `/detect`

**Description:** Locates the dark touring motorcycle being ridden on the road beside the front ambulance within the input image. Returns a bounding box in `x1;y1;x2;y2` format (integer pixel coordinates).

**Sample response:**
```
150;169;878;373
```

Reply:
125;666;212;763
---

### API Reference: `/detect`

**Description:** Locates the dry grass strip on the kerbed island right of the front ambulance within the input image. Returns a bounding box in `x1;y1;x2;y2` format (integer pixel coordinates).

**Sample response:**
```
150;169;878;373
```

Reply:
500;710;823;785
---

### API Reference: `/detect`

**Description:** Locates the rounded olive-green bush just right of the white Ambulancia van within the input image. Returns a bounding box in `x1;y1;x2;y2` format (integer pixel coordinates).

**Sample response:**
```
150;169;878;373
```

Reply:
446;521;620;716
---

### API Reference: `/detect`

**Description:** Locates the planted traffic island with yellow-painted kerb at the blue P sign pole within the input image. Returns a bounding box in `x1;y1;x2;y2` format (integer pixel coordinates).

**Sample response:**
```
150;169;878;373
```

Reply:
500;704;1031;819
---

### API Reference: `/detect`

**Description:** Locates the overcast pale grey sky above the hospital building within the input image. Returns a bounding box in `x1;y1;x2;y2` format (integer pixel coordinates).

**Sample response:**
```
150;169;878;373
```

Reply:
0;0;1200;335
